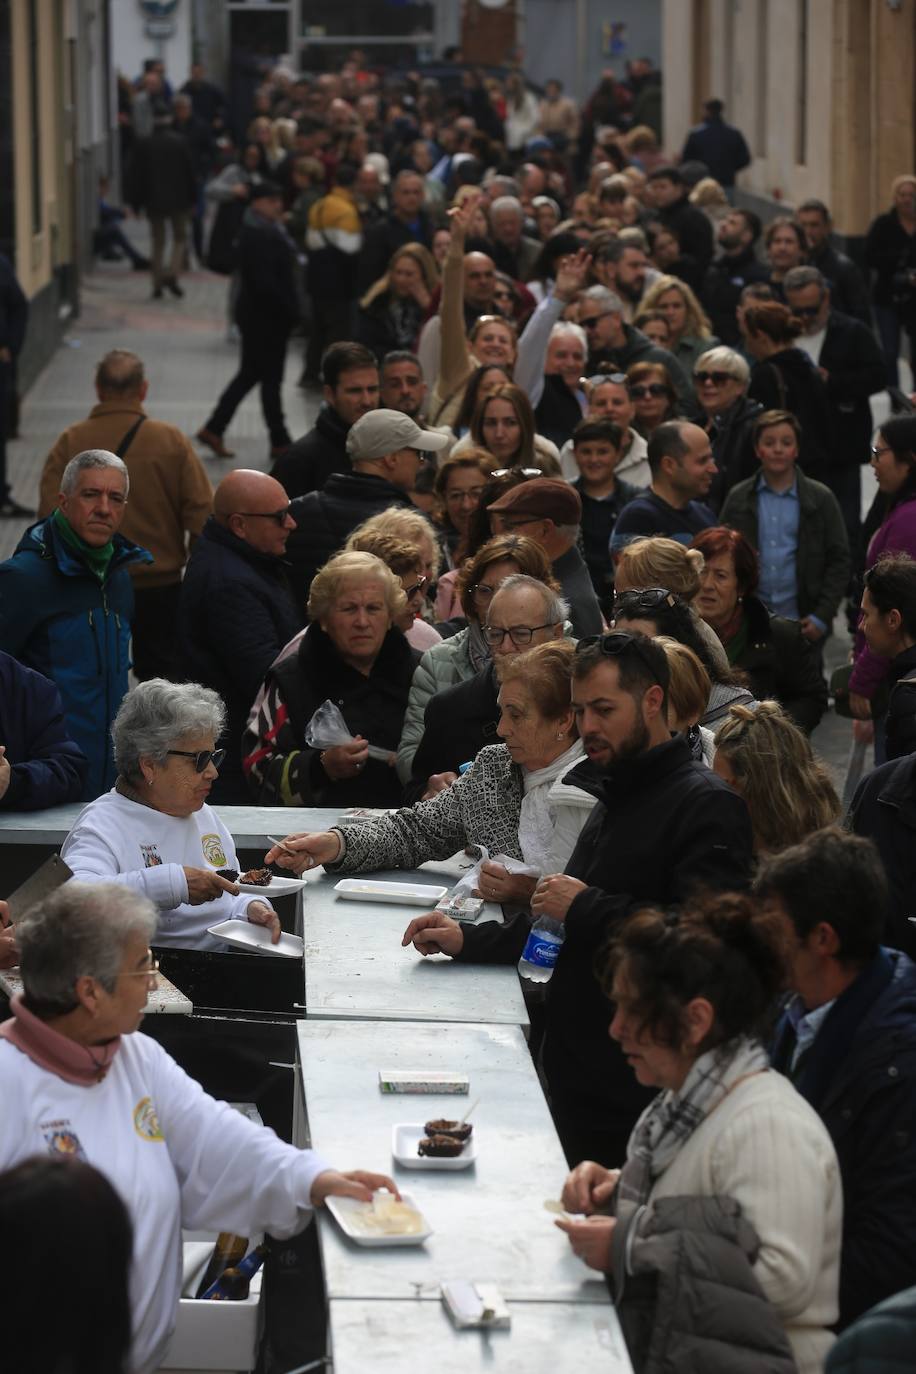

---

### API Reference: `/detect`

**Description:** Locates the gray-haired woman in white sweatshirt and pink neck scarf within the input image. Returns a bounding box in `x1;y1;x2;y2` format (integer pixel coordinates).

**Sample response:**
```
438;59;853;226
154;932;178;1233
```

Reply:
0;879;397;1374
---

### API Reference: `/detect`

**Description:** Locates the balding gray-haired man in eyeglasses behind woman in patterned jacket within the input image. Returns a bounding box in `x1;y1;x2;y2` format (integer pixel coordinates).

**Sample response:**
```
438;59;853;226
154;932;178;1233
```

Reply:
405;573;569;801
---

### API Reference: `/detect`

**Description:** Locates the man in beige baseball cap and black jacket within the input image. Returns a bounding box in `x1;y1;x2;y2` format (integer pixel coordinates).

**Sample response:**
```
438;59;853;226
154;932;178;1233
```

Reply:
287;409;449;614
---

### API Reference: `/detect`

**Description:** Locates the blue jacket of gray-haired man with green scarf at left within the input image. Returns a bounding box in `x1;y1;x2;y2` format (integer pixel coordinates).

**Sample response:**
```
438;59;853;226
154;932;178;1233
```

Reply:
0;519;152;801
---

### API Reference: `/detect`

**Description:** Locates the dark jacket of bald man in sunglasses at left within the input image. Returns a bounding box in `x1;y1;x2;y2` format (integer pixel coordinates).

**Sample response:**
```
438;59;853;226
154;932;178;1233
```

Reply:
177;515;302;802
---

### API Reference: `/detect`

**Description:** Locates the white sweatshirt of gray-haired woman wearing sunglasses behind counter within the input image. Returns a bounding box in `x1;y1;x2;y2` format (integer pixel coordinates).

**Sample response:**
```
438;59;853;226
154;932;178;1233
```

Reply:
60;789;269;951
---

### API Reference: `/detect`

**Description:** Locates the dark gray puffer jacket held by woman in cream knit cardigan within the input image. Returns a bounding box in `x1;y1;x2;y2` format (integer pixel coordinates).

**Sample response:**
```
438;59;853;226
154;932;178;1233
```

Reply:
608;1197;797;1374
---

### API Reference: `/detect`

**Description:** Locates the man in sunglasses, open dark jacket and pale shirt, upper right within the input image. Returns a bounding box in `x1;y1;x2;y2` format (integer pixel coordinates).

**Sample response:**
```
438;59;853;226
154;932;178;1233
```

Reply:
783;267;886;548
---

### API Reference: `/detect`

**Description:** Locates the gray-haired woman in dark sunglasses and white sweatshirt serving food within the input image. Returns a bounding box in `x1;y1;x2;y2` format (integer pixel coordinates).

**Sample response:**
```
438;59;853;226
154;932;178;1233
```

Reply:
60;677;280;951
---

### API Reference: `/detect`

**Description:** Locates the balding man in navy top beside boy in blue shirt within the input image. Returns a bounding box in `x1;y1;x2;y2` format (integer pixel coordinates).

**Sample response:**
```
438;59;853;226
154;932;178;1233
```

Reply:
611;420;717;554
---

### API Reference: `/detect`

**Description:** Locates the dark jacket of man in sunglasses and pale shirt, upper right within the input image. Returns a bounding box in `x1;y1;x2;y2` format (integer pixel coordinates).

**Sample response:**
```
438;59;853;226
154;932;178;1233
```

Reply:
820;311;886;467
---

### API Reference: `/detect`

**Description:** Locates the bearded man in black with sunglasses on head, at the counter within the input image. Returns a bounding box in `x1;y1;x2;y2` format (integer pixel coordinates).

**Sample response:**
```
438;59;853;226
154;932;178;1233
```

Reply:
404;632;753;1167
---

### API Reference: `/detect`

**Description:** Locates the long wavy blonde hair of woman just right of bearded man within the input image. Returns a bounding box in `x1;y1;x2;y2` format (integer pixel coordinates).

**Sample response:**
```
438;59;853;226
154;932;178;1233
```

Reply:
713;701;842;855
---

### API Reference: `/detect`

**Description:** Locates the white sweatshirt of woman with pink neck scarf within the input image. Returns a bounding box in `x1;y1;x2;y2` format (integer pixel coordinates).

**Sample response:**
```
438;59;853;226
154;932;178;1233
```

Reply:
0;1033;331;1374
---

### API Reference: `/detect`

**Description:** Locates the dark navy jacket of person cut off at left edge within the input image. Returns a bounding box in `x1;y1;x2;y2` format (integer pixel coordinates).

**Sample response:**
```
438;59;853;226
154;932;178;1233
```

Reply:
0;653;89;811
